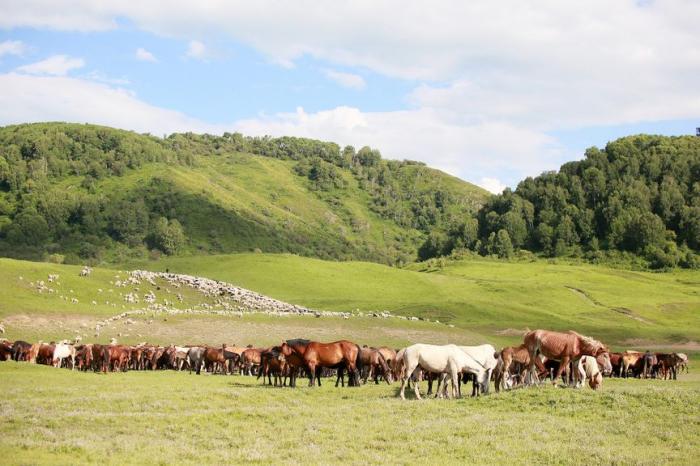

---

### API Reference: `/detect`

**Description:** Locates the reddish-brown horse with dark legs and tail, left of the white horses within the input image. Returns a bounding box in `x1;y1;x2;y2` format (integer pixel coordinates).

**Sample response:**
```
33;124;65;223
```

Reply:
281;340;360;387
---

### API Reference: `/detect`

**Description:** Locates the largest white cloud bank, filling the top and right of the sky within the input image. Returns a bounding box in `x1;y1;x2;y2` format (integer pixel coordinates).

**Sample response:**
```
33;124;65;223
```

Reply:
0;0;700;186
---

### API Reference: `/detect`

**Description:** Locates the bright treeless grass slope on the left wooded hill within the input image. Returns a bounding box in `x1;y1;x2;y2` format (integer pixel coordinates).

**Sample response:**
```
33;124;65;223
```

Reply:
47;147;487;260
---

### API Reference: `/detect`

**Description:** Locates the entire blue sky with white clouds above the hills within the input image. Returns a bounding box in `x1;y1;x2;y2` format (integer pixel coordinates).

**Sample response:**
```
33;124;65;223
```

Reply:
0;0;700;191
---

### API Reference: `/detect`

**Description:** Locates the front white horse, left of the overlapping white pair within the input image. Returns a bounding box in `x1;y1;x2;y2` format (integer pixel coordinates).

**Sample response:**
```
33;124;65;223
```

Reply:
400;343;481;400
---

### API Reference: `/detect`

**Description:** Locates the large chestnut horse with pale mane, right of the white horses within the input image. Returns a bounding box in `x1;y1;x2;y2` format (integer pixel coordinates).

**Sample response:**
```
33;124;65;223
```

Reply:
524;330;609;384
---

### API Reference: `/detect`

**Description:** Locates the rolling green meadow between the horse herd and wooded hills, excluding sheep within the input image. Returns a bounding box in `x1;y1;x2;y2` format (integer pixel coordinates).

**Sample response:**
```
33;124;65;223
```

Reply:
0;254;700;353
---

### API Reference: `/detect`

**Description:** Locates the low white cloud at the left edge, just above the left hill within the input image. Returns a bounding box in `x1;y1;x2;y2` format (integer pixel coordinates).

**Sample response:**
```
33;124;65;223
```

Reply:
0;73;225;136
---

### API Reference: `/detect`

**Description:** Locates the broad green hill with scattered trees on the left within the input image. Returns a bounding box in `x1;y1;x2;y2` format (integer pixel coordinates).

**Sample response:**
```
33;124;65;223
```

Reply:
0;123;487;264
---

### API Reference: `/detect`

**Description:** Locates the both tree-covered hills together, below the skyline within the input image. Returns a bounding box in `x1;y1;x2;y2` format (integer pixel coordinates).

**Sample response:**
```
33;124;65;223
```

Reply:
0;123;700;268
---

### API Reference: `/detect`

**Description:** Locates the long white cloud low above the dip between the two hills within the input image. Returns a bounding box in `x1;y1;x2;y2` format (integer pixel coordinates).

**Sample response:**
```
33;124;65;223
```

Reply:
234;107;561;187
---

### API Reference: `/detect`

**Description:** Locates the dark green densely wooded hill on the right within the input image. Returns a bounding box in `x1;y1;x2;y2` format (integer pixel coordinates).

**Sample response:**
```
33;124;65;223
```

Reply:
430;135;700;268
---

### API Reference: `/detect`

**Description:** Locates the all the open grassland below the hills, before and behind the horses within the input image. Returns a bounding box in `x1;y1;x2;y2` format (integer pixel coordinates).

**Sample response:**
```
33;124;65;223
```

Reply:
0;254;700;464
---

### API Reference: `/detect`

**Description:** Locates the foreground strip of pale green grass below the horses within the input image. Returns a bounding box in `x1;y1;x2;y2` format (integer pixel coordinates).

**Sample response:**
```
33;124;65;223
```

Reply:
0;362;700;465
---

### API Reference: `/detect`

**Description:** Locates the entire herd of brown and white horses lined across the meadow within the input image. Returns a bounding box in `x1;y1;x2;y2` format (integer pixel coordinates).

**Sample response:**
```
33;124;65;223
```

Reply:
0;330;688;399
